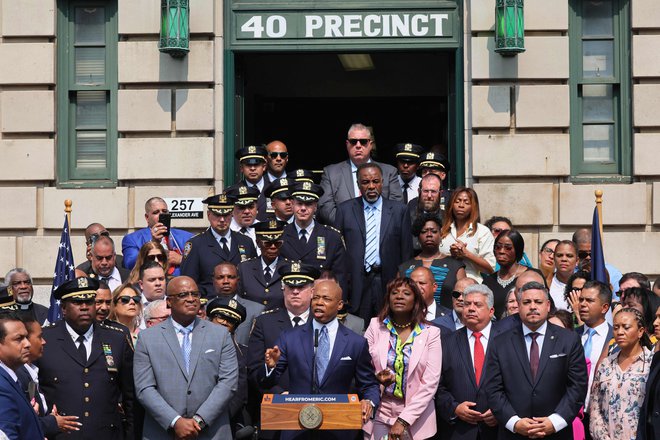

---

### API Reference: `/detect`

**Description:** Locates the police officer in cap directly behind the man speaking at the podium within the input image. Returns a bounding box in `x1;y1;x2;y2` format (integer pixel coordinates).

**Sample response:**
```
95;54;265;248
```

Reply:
248;262;320;438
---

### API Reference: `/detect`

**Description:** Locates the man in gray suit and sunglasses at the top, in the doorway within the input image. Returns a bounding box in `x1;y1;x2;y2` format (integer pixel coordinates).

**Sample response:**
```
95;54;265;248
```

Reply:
319;124;403;225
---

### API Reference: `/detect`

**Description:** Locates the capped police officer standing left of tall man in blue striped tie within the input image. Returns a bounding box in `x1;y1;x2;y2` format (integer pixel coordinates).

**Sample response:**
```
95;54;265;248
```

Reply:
281;182;348;290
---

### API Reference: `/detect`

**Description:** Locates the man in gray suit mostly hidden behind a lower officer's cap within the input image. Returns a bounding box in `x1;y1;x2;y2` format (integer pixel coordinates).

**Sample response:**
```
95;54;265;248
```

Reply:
207;261;266;345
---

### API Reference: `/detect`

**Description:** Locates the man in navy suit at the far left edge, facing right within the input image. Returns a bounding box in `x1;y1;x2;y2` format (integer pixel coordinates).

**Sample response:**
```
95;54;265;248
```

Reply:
0;308;44;440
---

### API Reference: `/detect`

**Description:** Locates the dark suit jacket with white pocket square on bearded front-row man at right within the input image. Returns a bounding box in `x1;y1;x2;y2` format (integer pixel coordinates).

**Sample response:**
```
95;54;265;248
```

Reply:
483;323;588;440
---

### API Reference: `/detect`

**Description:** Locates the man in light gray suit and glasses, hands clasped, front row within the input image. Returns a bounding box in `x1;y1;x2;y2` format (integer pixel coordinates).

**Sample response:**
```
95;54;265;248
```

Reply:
134;276;238;440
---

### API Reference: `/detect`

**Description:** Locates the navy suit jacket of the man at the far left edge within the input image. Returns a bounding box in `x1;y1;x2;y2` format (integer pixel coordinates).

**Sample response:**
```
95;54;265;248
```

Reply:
0;368;44;440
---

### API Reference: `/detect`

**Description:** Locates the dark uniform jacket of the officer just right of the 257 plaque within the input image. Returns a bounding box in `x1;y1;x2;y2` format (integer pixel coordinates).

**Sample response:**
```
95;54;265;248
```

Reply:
181;229;257;297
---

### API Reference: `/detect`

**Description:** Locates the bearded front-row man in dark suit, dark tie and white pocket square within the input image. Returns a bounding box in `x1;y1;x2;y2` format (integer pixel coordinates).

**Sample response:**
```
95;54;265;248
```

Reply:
483;281;587;440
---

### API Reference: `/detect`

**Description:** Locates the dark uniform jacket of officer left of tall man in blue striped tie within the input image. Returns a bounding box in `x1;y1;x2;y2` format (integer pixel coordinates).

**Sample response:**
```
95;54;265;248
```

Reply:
280;222;348;290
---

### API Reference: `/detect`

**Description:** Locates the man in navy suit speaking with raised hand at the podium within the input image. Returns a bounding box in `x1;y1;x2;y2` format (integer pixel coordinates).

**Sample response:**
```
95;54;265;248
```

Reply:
261;270;380;440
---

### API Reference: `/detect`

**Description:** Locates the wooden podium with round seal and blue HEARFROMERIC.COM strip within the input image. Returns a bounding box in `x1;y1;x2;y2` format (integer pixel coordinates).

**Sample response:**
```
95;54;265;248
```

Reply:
261;394;362;431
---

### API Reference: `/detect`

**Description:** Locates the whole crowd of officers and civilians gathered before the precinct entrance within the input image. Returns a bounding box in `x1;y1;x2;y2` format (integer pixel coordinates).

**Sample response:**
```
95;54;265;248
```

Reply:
0;124;660;440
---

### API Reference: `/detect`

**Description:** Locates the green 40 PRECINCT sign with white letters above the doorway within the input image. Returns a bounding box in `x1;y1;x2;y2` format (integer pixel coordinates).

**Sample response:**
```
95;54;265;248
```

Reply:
232;8;460;49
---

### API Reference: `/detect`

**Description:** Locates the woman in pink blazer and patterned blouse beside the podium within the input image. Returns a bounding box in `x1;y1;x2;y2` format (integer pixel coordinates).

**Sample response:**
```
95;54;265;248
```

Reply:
363;278;442;440
